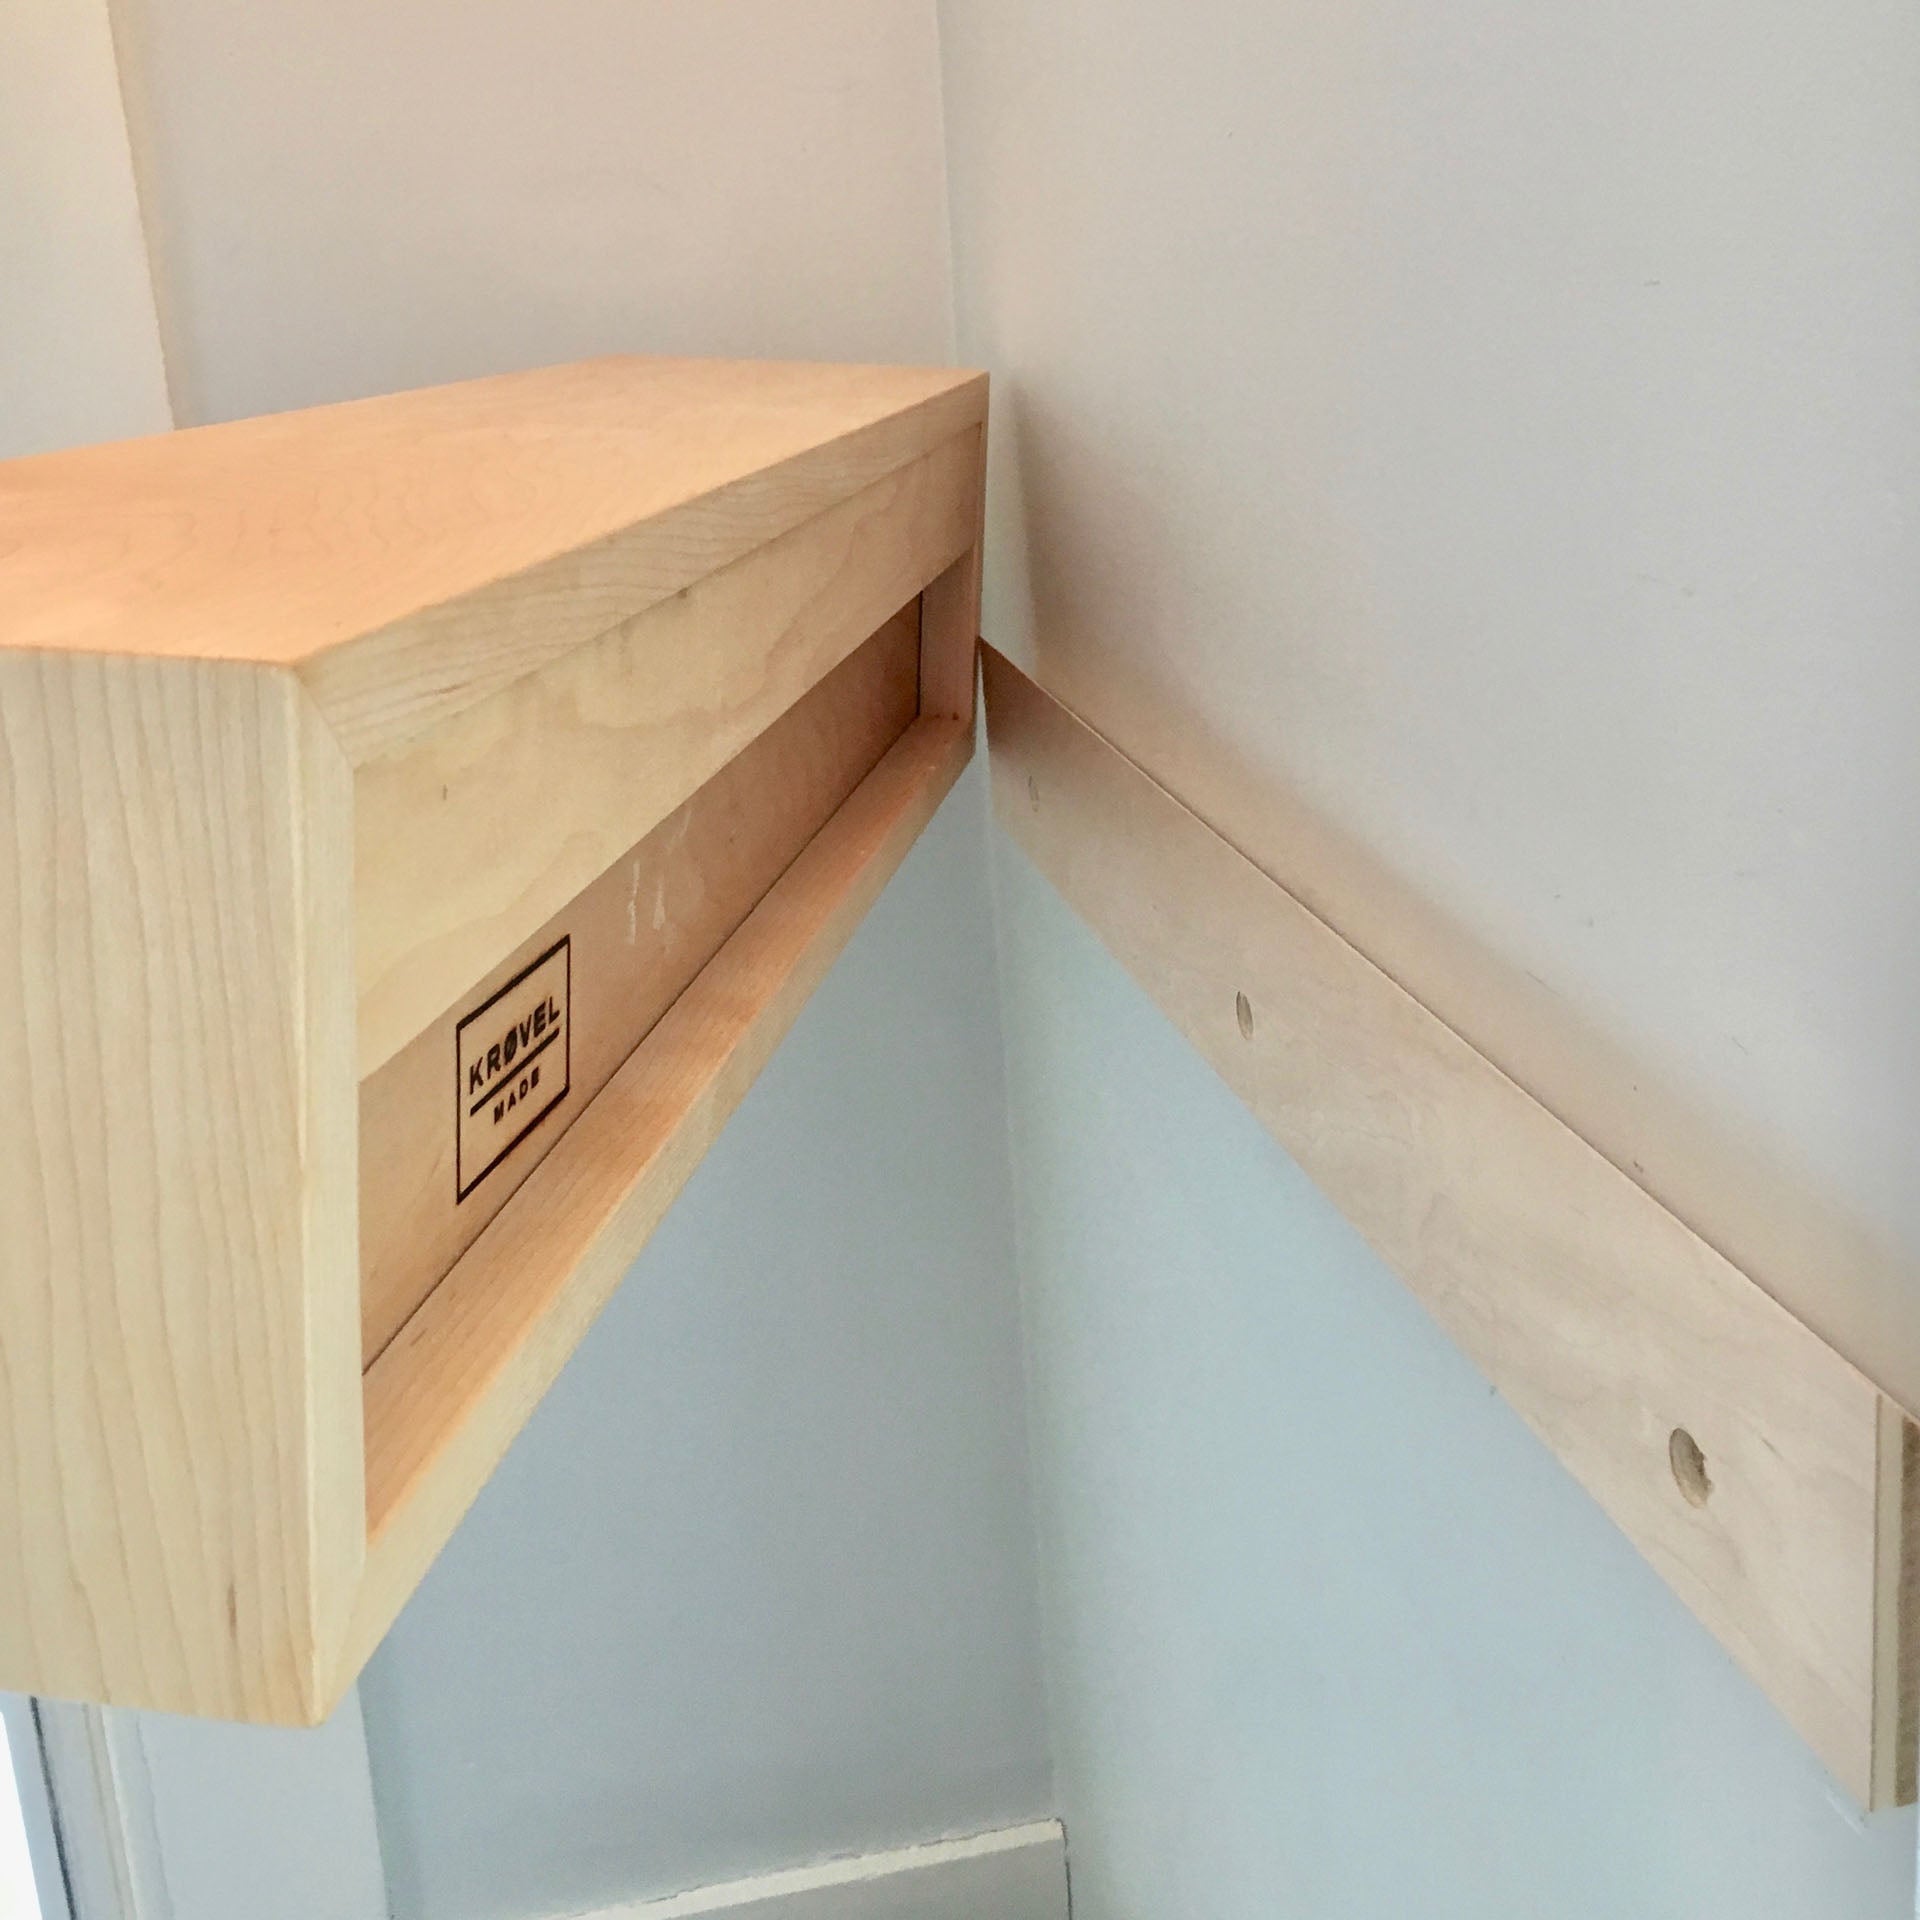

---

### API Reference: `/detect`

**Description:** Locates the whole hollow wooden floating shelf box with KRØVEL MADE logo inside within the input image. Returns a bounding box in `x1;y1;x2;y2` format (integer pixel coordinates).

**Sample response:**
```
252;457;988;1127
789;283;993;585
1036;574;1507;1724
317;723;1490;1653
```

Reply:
0;361;987;1722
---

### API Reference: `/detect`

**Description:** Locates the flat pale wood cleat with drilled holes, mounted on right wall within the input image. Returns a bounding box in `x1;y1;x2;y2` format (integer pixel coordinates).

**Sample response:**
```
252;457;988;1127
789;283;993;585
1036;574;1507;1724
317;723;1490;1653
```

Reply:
985;651;1916;1805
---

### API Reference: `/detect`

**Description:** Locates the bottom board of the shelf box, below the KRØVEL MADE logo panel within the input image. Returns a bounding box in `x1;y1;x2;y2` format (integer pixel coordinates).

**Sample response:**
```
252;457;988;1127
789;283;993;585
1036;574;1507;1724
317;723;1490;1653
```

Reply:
342;720;972;1684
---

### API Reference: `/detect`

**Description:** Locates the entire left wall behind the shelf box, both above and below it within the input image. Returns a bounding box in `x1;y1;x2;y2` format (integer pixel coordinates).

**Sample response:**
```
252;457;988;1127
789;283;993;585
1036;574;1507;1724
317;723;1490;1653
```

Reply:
97;0;1050;1920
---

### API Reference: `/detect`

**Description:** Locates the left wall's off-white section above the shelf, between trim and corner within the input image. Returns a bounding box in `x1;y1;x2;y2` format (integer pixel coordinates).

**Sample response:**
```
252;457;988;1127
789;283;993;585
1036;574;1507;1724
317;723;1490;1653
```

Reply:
108;0;952;420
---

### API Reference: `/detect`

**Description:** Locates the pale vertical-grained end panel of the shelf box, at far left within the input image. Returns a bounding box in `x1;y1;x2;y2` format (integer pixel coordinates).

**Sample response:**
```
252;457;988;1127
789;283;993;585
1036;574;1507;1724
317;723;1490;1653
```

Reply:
0;653;365;1720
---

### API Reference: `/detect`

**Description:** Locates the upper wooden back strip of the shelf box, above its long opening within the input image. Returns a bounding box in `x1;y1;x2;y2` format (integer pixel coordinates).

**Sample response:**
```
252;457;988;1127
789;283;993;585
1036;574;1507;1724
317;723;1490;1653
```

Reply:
353;432;979;1075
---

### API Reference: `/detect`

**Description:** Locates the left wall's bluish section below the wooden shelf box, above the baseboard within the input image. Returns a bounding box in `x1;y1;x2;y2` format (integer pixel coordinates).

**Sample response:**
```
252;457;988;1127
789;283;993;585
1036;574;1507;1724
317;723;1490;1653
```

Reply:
361;768;1052;1920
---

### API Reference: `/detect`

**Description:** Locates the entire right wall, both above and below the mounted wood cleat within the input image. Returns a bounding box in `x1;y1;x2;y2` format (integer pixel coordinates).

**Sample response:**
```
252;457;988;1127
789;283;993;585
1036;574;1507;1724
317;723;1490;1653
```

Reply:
943;0;1920;1920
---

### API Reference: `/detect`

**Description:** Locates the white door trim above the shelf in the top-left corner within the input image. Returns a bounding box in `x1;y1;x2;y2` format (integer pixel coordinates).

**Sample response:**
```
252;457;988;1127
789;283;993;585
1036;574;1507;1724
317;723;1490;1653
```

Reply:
0;0;173;459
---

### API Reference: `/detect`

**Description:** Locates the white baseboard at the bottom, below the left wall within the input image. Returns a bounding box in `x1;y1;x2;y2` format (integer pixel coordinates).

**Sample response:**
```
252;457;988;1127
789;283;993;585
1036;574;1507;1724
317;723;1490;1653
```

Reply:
572;1820;1068;1920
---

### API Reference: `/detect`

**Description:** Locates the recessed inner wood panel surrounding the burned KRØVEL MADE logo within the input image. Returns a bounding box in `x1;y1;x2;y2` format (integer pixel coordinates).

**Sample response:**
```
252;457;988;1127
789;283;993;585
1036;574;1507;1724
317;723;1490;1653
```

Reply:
359;603;920;1361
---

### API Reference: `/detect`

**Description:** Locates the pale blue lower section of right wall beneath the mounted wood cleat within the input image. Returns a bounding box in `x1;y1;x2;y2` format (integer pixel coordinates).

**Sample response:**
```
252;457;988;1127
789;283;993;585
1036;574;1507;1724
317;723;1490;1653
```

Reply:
996;841;1914;1920
